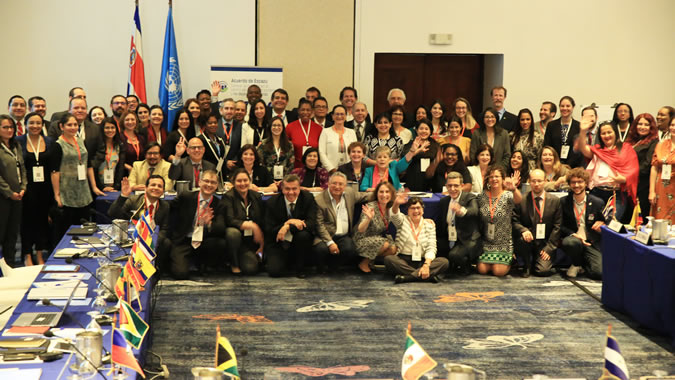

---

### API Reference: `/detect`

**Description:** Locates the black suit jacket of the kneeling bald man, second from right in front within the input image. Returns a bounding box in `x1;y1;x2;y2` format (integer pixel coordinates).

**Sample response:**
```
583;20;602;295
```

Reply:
512;191;562;254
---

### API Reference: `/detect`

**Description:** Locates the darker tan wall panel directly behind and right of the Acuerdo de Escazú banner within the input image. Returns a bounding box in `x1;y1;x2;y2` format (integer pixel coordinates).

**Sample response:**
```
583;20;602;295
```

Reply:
258;0;354;108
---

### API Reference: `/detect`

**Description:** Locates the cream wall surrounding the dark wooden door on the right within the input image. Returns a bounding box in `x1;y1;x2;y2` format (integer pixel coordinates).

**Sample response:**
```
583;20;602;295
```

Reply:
354;0;675;114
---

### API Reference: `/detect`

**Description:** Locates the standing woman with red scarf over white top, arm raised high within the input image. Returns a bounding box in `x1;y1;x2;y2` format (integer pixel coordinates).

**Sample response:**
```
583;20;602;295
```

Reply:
577;117;640;222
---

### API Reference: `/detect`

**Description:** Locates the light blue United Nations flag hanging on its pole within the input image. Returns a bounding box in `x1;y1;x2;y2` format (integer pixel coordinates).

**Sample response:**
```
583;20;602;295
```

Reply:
159;6;183;130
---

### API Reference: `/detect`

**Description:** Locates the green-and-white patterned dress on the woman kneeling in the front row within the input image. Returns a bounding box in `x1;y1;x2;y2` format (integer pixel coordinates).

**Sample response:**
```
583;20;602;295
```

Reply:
478;191;513;265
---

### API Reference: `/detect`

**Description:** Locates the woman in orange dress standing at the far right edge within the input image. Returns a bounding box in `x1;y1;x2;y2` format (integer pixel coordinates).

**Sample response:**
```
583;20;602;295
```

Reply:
649;117;675;223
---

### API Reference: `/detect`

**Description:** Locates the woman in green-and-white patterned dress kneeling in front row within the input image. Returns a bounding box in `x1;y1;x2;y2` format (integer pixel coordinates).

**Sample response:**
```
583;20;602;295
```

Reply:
477;165;521;277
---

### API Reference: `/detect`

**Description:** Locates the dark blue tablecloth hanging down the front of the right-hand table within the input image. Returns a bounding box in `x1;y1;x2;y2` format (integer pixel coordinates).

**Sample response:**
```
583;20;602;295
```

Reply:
602;227;675;346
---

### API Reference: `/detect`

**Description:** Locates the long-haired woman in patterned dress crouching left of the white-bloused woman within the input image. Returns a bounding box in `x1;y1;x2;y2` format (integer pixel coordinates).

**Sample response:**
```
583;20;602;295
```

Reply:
354;181;396;273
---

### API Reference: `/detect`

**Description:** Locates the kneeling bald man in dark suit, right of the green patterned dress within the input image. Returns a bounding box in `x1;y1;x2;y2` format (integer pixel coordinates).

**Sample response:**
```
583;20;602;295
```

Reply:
513;169;562;277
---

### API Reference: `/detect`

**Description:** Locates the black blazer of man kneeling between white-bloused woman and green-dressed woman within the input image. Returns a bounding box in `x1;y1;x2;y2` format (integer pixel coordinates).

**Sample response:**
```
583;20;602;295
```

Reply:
436;191;480;244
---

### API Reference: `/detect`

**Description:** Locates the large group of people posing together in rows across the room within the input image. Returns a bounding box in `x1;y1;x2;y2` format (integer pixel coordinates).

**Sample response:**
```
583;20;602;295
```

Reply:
0;82;675;283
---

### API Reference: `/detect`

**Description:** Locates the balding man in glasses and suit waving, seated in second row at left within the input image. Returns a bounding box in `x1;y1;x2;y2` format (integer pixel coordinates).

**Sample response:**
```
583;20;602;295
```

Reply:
169;137;216;188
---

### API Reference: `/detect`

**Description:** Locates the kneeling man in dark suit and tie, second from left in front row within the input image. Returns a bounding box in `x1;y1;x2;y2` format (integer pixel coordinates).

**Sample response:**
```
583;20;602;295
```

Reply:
171;169;226;279
